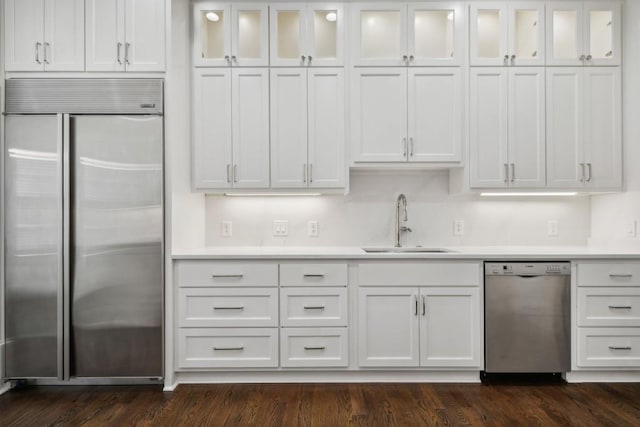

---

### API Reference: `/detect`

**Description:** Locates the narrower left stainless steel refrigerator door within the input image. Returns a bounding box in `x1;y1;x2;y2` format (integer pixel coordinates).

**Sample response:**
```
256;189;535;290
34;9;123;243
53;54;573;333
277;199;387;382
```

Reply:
4;115;63;379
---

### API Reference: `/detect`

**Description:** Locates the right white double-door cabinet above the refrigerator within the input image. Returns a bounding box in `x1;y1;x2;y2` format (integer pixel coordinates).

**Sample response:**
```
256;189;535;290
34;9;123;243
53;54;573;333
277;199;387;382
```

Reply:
86;0;166;71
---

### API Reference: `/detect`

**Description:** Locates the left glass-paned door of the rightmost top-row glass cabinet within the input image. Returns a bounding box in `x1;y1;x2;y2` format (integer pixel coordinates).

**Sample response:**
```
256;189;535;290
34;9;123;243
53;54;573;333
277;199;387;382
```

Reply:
546;2;587;65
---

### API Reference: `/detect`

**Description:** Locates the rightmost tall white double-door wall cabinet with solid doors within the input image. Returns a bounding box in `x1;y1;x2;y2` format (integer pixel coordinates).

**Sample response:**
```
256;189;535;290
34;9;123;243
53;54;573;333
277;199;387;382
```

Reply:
547;67;622;190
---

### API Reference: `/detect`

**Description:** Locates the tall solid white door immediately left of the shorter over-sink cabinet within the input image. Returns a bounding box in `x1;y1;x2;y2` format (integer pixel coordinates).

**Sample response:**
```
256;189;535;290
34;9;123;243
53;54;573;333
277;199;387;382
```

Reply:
308;68;346;188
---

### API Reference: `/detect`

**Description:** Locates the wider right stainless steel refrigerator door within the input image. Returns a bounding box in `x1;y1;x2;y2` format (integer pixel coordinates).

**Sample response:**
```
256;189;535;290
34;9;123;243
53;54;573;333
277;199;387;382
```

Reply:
70;116;163;378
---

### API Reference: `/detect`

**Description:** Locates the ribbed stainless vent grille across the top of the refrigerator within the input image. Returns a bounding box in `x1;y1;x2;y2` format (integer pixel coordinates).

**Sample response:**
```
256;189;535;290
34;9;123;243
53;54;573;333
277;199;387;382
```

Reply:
6;79;163;114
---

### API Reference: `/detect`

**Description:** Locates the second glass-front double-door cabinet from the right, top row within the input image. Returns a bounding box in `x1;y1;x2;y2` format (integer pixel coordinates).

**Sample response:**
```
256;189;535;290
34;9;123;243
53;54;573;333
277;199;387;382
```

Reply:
470;2;545;66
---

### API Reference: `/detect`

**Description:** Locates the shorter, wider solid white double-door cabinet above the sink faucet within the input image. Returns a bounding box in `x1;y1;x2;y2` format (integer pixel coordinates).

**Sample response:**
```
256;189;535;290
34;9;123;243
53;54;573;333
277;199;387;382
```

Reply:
351;67;463;163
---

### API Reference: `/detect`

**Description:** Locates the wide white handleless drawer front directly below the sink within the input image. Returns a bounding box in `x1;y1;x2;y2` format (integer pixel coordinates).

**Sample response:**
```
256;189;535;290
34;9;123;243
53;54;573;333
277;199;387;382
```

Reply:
358;262;482;286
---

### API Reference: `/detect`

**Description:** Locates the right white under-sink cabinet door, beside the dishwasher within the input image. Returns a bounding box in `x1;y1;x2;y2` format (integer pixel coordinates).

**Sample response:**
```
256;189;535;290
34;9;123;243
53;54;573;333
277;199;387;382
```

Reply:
420;288;483;368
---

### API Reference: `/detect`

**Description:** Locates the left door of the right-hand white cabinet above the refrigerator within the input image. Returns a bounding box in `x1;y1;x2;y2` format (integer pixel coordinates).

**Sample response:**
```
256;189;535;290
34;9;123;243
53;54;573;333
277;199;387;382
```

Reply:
85;0;125;71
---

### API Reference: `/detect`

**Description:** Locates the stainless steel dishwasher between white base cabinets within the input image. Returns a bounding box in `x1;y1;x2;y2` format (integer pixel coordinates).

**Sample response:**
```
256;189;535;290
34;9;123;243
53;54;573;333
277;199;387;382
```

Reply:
484;262;571;373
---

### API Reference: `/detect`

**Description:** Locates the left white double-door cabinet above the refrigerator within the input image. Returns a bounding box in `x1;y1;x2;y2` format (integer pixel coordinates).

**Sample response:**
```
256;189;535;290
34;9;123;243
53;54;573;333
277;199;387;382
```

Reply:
4;0;84;71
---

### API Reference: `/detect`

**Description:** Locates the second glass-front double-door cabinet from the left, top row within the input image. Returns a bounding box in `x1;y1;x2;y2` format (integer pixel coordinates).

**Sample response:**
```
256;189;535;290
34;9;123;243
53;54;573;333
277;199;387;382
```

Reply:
270;2;344;67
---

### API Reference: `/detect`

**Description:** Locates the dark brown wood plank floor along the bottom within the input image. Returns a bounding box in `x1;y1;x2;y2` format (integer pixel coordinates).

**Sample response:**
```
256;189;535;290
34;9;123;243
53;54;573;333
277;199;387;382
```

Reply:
0;384;640;427
